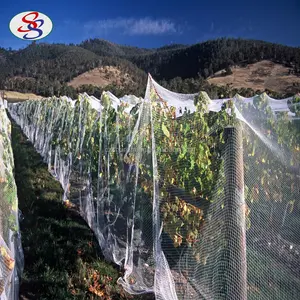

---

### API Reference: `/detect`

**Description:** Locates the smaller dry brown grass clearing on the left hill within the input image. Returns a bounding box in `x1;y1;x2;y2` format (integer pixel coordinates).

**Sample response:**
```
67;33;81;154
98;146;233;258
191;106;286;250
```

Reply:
68;66;133;88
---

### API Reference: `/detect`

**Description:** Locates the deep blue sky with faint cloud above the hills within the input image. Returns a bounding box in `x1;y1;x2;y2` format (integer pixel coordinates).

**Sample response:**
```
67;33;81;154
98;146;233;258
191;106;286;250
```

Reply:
0;0;300;49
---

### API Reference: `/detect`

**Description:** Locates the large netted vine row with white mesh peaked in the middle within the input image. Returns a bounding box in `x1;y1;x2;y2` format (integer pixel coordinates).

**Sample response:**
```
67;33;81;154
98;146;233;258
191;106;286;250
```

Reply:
9;76;300;300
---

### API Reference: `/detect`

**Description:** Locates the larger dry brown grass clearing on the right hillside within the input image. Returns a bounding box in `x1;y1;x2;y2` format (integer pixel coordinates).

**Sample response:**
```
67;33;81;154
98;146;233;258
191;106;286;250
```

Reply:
208;60;300;93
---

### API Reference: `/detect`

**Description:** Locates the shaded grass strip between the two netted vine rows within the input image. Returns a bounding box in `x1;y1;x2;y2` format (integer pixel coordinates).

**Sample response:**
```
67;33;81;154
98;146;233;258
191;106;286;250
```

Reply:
12;119;153;300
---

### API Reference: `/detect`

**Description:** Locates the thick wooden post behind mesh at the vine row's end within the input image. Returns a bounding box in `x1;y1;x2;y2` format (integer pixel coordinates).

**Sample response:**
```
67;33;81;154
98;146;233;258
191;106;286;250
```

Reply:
224;125;247;300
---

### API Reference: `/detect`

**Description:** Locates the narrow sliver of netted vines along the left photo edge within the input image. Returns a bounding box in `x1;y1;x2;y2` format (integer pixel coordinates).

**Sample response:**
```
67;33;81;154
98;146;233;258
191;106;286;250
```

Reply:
0;97;23;300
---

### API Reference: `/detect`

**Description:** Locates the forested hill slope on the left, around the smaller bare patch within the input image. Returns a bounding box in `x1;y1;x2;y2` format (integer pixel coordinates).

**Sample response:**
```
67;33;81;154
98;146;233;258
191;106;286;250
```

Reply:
0;43;147;97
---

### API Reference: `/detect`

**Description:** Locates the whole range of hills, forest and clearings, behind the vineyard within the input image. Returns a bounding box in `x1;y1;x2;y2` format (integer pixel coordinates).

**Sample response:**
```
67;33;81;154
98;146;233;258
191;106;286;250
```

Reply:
0;38;300;97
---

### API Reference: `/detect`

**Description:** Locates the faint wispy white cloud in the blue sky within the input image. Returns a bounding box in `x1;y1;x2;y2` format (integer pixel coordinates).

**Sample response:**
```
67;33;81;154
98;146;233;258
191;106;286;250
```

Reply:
84;18;181;35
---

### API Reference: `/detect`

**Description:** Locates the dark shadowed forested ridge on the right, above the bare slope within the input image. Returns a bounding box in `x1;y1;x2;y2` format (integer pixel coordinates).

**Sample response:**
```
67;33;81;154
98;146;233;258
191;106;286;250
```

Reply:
130;38;300;80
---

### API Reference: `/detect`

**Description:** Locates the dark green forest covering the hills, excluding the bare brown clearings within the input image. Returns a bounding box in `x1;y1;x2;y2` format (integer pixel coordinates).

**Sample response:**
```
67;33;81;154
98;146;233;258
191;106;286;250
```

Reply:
0;38;300;97
